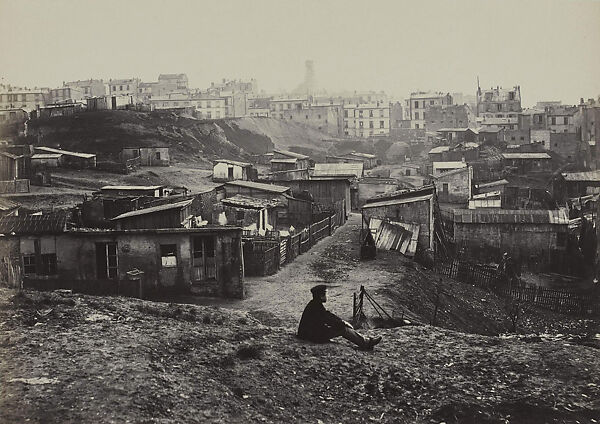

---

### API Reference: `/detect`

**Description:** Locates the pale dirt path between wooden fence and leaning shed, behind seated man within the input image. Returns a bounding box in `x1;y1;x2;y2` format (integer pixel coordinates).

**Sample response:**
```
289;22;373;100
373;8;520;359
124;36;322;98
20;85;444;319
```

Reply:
176;213;412;328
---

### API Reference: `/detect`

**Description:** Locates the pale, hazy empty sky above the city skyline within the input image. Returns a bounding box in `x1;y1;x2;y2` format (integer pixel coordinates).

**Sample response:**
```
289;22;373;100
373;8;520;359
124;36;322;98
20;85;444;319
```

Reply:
0;0;600;106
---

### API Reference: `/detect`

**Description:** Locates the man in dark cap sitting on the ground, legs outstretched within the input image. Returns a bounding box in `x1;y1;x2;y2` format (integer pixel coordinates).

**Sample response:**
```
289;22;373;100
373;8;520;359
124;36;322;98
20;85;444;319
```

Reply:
298;284;381;350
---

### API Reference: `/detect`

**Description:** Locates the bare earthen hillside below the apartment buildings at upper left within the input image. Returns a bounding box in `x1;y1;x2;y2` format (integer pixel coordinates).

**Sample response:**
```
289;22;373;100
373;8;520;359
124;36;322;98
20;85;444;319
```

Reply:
28;111;326;164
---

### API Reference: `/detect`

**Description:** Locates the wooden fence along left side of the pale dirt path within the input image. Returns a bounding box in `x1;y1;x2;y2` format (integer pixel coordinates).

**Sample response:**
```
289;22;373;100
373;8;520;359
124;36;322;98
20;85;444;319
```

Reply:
243;212;340;276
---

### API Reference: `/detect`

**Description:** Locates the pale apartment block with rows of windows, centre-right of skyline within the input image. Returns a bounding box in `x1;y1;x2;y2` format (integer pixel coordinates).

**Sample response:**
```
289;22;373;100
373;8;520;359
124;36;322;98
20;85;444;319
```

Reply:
343;103;390;138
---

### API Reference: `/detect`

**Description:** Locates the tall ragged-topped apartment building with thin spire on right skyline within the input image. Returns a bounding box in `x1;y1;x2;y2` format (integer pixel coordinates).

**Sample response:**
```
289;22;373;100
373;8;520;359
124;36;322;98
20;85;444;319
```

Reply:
476;85;522;130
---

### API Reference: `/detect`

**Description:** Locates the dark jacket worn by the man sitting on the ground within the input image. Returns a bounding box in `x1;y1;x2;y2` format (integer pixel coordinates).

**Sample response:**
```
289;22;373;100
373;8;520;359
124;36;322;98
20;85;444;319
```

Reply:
298;299;345;343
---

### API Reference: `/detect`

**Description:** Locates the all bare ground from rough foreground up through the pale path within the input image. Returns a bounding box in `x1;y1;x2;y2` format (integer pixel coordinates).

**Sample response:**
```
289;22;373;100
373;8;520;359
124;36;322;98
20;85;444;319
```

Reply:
0;215;600;424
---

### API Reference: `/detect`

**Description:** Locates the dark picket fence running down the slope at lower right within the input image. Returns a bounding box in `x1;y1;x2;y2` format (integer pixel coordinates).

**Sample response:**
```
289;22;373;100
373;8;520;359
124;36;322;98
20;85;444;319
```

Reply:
435;258;600;315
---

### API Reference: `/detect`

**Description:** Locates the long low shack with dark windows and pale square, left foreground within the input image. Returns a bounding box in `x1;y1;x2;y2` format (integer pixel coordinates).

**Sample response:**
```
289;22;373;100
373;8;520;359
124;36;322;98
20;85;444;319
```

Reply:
0;215;244;298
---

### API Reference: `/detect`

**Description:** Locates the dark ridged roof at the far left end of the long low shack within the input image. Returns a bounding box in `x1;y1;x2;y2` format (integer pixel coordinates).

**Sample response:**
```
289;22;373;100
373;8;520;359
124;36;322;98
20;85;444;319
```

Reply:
0;212;69;235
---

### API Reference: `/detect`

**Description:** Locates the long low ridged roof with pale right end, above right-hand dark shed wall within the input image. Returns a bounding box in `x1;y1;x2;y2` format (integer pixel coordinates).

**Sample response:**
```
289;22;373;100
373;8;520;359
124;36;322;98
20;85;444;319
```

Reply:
454;209;569;225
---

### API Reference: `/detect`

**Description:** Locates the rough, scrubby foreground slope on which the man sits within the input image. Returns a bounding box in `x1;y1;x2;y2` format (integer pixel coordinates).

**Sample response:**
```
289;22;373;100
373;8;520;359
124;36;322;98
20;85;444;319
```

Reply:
0;289;600;423
